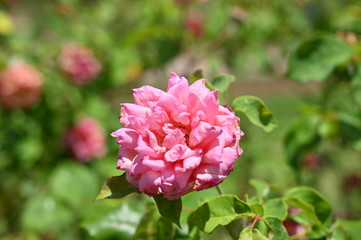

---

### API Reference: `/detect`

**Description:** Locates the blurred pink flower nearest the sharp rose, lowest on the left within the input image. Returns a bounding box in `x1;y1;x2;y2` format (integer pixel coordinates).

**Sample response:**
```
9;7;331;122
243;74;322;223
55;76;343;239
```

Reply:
65;118;107;162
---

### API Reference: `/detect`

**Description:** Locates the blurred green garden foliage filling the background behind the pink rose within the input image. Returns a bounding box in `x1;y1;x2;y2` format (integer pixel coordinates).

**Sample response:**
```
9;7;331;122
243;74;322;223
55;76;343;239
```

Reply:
0;0;361;239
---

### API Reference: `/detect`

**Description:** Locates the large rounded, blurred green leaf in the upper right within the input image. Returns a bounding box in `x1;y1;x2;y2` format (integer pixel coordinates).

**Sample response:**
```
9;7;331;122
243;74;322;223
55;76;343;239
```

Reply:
288;36;352;82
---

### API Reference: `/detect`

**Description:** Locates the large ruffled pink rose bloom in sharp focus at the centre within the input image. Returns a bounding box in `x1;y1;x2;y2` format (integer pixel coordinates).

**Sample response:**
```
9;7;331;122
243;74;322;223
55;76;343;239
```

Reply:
112;73;243;200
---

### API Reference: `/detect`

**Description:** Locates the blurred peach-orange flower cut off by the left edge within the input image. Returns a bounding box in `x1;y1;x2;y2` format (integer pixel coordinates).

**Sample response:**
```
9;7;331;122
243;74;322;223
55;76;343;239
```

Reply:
0;63;43;108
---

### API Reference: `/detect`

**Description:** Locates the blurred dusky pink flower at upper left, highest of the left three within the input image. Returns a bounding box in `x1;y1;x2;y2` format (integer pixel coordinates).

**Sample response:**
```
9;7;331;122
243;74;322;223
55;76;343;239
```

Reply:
59;43;102;85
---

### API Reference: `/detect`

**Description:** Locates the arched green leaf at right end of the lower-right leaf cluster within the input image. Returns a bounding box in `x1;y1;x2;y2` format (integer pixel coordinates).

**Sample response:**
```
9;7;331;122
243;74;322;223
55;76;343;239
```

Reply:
285;187;331;223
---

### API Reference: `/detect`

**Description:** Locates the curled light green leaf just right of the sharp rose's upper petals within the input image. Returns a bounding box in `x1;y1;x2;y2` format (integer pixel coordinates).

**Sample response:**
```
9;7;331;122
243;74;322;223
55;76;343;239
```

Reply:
233;96;277;132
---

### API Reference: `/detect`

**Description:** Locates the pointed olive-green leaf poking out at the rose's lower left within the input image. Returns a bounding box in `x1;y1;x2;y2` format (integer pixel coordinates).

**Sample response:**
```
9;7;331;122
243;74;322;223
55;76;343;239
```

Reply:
94;173;140;201
